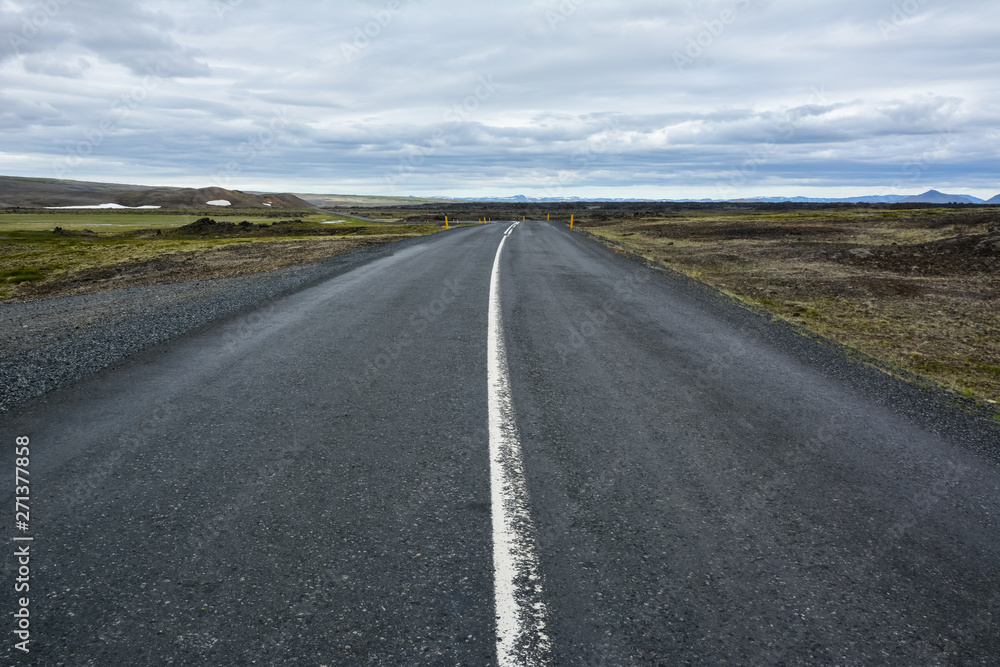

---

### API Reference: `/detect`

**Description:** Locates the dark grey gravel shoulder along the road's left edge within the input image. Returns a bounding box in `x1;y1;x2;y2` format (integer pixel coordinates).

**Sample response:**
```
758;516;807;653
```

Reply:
0;237;425;412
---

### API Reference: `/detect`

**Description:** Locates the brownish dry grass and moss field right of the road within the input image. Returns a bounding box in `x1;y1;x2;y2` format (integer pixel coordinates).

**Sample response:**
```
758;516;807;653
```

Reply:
583;207;1000;414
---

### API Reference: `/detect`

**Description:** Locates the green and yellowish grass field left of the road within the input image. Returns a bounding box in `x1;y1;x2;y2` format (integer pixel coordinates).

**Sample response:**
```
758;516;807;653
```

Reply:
0;209;440;301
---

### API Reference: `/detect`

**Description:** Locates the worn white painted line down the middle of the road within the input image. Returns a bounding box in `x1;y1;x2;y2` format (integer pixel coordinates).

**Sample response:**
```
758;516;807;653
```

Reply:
487;223;550;667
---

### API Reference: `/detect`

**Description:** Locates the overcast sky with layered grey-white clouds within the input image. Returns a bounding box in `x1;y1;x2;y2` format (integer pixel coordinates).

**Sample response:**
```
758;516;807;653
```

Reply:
0;0;1000;198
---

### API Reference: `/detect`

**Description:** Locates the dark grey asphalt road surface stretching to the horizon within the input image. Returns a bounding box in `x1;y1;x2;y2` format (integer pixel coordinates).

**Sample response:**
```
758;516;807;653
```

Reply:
0;221;1000;666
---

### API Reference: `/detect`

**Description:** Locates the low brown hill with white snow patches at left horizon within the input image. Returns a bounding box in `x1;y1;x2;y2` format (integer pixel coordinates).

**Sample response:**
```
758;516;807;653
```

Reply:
0;176;312;209
